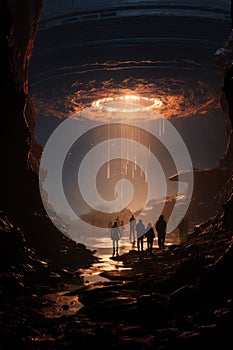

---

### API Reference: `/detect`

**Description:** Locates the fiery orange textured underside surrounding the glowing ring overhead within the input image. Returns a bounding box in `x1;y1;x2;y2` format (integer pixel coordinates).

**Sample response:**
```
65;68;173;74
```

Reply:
35;77;221;120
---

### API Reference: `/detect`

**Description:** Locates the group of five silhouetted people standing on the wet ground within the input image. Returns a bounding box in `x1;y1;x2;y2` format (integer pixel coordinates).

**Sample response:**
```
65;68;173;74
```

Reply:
109;215;167;256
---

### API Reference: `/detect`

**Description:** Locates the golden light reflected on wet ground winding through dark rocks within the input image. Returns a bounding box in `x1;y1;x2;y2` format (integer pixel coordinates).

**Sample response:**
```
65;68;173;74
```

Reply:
41;233;179;318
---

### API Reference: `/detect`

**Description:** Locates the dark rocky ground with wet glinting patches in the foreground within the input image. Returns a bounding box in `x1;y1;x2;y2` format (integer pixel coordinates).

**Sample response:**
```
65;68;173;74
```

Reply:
2;227;233;350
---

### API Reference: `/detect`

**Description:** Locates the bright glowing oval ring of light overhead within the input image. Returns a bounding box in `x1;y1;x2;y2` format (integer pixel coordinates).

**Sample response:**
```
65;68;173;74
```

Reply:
92;95;163;113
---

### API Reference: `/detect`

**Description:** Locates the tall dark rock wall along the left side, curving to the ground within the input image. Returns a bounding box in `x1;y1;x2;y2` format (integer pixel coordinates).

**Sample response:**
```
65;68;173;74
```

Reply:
0;1;94;265
